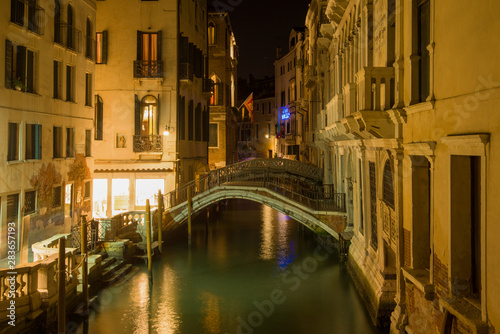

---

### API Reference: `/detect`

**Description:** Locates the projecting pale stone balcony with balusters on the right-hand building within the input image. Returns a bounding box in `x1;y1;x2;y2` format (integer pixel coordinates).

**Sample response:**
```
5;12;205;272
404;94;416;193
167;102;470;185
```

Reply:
356;67;394;111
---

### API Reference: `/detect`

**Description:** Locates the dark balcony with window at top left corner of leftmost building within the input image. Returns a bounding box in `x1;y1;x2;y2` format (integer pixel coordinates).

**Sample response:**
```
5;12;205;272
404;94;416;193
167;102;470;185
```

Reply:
10;0;45;35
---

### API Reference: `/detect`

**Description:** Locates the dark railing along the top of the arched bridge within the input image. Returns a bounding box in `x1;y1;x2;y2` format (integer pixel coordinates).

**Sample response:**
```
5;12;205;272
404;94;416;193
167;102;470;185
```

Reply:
164;163;346;212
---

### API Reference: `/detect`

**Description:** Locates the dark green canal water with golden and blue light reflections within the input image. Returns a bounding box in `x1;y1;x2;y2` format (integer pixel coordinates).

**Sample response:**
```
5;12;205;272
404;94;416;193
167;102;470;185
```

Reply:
79;200;385;334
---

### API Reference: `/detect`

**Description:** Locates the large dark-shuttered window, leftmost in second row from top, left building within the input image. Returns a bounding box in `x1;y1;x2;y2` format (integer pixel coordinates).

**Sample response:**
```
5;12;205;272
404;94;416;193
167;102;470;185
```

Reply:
5;40;36;93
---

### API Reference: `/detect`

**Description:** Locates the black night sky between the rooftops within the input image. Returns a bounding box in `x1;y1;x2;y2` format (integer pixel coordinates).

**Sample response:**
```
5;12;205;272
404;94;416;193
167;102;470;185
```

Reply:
221;0;311;78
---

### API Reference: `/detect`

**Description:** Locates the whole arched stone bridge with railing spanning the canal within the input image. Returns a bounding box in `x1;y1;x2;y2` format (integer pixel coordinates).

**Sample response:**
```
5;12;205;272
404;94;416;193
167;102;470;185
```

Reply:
163;159;346;239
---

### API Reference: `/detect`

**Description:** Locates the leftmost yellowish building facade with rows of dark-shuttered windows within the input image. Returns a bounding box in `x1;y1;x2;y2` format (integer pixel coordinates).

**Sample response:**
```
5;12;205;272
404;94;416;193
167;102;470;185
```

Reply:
0;0;96;262
